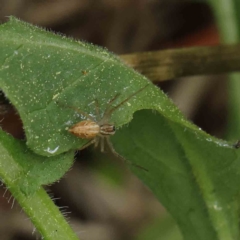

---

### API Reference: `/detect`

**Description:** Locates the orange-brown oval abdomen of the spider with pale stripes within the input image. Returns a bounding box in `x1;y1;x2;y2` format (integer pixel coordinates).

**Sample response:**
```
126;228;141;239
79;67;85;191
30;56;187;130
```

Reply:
68;120;100;139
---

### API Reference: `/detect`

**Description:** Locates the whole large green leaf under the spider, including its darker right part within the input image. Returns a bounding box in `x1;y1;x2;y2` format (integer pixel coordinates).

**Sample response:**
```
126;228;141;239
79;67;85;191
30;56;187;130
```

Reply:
0;18;240;240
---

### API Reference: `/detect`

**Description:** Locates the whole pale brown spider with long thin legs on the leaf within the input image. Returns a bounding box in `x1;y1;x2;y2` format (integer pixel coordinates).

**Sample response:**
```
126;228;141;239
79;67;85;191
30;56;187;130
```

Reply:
64;84;150;170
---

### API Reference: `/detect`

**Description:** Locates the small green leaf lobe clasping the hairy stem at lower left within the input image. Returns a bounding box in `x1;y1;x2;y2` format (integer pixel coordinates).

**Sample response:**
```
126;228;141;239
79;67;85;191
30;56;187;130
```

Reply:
0;130;74;195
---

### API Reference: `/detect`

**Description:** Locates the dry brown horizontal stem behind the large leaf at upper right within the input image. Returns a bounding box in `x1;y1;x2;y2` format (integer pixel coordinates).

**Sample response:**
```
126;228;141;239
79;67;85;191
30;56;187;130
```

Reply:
121;44;240;82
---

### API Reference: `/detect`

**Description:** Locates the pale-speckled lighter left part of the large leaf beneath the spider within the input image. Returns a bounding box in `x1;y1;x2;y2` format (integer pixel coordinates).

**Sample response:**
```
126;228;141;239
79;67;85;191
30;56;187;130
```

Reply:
0;18;183;156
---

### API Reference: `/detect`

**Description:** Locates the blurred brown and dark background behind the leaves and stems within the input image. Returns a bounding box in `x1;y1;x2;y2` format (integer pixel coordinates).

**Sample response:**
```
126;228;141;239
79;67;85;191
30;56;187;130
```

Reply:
0;0;227;240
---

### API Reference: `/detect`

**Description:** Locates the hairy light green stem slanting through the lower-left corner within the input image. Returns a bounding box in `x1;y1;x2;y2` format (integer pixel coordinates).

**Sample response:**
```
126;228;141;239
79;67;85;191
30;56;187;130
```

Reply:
0;132;78;240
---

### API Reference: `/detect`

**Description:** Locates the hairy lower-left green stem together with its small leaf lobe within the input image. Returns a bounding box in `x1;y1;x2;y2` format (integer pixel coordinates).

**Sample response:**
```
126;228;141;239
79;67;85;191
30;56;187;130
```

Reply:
0;131;77;239
